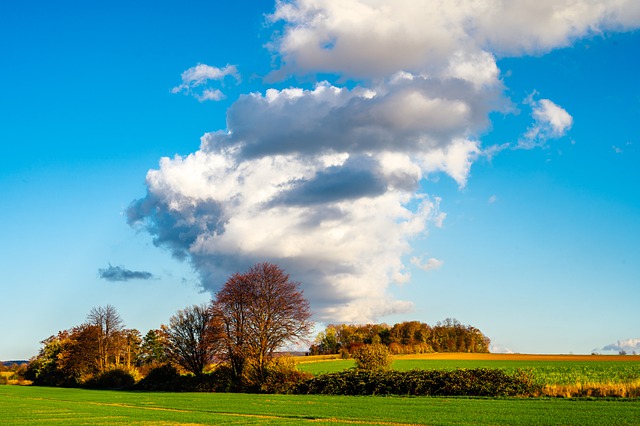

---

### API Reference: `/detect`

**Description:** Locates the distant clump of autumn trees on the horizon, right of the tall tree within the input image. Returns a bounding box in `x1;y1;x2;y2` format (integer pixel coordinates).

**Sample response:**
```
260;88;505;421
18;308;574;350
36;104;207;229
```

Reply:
309;318;491;356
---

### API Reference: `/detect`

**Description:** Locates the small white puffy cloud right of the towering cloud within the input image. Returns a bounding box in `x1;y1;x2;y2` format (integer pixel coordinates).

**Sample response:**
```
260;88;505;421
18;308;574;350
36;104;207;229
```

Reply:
518;99;573;149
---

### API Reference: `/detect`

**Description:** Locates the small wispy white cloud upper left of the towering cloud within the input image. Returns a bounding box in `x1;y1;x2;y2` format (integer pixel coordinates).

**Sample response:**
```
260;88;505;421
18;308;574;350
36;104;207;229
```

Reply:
171;64;240;102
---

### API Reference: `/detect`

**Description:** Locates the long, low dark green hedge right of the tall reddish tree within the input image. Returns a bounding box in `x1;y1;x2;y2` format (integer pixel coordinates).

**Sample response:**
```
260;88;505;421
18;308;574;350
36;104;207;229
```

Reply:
297;368;539;396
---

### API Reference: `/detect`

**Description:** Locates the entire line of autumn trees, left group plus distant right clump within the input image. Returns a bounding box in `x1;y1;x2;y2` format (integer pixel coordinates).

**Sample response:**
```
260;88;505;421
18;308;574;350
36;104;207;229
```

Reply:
25;263;489;390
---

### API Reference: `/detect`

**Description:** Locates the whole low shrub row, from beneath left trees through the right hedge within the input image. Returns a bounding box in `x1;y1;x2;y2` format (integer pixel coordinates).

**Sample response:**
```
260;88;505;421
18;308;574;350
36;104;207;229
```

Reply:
74;364;541;396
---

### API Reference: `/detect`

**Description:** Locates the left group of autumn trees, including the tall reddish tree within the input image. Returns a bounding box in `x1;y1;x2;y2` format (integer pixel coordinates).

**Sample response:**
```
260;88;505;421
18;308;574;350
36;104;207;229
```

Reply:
26;263;312;390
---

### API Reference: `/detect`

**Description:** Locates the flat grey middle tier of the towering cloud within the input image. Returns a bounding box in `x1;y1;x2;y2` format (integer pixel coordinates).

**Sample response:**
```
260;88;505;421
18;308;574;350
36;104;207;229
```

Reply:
222;76;500;161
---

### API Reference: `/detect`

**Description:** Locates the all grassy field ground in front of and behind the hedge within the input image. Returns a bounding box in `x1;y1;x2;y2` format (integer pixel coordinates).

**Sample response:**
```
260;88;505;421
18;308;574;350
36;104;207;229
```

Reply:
0;354;640;425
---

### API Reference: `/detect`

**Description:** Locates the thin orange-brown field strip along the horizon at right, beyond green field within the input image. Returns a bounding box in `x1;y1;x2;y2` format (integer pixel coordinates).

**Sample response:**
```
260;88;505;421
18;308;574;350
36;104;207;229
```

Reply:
395;352;640;362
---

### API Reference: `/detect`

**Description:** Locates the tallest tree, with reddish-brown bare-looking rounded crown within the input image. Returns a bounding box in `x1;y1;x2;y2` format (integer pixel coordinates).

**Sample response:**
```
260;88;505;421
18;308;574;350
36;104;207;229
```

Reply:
213;263;312;380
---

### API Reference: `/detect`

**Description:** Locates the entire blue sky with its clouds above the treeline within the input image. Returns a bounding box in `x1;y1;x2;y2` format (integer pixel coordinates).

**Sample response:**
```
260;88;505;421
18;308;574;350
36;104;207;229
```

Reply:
0;0;640;359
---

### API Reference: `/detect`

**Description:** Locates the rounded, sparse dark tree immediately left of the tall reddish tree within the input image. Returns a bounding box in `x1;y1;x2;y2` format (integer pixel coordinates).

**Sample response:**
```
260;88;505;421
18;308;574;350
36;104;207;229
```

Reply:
162;305;220;375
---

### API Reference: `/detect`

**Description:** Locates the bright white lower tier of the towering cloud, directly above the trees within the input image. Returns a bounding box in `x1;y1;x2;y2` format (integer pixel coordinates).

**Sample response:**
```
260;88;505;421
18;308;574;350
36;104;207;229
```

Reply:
128;135;440;321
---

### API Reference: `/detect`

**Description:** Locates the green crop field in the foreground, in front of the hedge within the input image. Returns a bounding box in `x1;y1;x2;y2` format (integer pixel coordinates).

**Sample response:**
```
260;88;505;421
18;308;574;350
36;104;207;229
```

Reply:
0;386;640;426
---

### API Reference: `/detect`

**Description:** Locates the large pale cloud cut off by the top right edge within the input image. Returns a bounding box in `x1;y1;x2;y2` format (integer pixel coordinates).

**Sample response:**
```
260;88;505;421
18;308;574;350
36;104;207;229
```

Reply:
271;0;640;79
